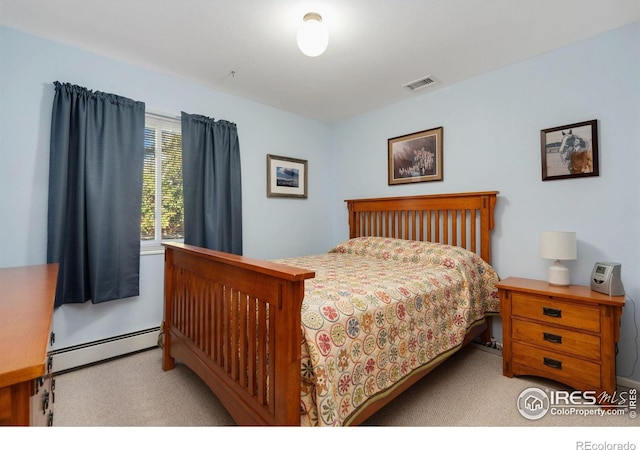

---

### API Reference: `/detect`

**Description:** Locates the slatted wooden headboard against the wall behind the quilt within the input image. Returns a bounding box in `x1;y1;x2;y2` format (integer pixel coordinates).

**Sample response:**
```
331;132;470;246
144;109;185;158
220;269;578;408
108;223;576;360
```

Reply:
345;191;498;263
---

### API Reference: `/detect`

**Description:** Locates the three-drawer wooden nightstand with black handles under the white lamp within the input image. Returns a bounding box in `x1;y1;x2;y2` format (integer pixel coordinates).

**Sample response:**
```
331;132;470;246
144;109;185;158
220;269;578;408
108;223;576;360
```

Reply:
497;277;625;395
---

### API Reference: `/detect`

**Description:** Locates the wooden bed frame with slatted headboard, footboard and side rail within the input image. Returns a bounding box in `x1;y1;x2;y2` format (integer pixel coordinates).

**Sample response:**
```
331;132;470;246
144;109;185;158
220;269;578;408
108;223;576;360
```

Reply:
162;192;497;425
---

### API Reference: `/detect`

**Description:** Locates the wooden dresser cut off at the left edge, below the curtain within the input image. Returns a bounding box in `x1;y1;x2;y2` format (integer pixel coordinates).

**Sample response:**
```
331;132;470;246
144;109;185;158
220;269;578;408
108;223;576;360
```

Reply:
0;264;58;425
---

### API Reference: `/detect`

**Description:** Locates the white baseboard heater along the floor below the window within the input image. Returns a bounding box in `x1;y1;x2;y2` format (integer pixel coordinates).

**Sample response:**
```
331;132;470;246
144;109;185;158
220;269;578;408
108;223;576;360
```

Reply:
49;327;160;374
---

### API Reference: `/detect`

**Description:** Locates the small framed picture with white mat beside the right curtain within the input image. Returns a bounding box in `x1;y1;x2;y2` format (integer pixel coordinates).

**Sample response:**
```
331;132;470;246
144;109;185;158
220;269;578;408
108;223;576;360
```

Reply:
267;155;307;198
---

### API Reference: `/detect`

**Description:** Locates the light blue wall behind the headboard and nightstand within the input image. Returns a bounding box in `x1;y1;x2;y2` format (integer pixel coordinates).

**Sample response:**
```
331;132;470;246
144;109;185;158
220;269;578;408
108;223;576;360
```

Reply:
329;23;640;380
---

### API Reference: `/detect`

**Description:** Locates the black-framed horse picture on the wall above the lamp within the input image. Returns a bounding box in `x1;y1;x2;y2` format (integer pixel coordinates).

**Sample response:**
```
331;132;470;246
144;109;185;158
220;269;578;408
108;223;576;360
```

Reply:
540;120;599;181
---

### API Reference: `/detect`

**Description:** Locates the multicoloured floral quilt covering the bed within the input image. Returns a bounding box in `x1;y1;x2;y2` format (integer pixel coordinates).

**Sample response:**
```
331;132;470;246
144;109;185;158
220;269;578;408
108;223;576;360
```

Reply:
278;237;500;426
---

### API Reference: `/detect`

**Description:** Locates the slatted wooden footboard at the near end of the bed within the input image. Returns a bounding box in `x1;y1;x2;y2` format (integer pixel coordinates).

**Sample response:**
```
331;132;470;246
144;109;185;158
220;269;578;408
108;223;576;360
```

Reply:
162;244;314;425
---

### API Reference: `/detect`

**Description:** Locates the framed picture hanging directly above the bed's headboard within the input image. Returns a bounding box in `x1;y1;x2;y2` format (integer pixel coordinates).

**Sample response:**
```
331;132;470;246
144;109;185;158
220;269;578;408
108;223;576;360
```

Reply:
388;127;443;185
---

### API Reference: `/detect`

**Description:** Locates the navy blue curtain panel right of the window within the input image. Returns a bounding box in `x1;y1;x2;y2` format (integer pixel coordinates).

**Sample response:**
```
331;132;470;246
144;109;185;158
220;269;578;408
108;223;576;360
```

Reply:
182;112;242;255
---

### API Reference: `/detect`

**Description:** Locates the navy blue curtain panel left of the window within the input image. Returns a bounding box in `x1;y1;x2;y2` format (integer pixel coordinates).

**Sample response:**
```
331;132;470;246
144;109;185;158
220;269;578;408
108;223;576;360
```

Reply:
47;81;145;307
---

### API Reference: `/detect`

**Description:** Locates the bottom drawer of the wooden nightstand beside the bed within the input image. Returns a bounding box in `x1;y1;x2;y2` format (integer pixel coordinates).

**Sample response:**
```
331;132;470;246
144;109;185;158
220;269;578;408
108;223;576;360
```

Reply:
513;342;601;387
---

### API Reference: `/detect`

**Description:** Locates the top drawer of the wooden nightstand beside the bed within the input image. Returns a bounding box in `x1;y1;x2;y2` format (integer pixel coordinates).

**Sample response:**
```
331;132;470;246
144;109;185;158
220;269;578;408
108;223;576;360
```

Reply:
511;292;600;333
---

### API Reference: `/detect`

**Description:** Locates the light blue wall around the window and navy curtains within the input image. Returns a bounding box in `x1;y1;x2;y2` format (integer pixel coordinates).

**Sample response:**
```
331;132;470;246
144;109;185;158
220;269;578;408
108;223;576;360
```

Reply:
0;27;333;348
